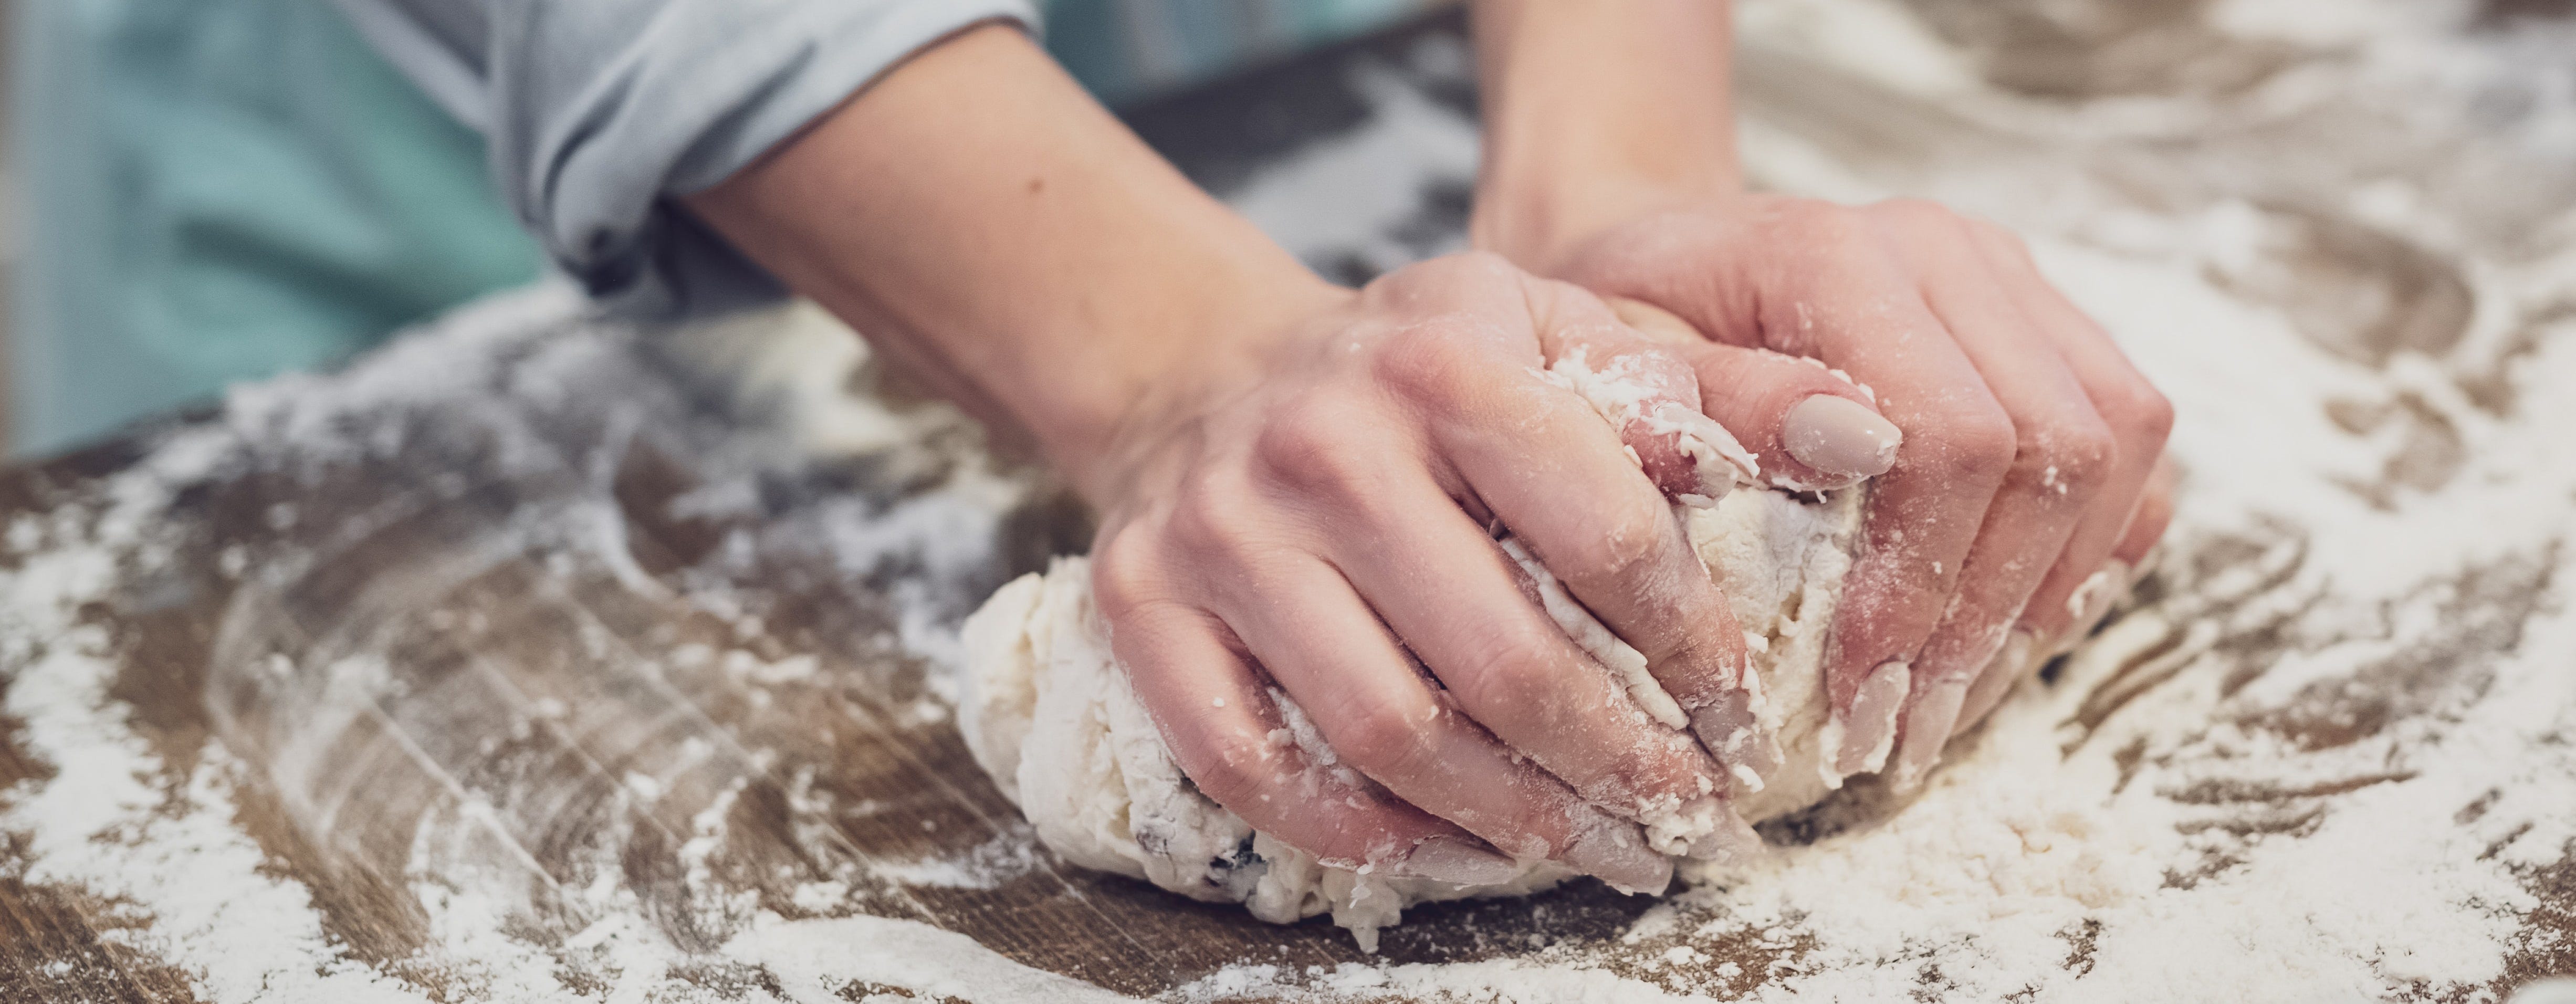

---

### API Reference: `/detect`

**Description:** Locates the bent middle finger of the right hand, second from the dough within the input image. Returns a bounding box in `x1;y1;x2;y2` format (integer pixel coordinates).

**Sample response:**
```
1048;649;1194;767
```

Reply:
1873;201;2118;788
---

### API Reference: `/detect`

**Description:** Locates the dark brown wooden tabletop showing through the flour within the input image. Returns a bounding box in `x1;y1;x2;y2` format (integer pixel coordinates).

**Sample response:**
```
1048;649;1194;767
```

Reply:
0;5;2576;1001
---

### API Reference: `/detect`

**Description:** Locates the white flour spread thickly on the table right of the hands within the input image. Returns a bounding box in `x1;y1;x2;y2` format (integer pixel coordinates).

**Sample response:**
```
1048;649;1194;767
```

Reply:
1169;3;2576;1001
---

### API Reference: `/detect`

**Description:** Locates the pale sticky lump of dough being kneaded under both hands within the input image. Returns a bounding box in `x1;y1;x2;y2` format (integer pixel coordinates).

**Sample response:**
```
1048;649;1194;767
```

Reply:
958;489;1860;950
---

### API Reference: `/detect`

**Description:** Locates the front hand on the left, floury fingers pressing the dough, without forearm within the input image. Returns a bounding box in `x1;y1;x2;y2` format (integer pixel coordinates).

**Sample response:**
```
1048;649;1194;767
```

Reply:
1087;255;1883;891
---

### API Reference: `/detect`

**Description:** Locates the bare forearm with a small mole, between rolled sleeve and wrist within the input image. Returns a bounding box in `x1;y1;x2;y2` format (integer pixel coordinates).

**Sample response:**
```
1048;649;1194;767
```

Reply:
688;26;1347;497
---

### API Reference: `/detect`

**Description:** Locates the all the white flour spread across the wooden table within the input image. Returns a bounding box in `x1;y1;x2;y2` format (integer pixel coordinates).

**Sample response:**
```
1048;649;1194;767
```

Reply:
0;0;2576;1004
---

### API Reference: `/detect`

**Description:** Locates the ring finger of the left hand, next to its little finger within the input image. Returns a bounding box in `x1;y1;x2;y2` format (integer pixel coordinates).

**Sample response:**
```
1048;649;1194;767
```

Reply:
1219;559;1672;893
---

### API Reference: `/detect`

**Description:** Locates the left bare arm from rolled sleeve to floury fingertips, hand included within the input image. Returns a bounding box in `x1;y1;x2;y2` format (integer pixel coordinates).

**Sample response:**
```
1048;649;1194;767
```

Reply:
688;28;1886;888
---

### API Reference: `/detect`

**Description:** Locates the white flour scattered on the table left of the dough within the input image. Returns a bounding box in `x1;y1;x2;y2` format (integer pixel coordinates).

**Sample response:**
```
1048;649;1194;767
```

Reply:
0;286;1056;1004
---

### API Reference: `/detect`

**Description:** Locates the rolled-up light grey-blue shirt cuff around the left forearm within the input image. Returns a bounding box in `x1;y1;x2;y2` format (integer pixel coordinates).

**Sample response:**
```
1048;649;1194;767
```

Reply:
518;0;1038;322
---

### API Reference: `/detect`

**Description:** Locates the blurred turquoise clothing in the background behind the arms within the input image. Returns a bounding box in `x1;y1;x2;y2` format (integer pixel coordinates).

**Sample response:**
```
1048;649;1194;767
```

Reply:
0;0;1442;458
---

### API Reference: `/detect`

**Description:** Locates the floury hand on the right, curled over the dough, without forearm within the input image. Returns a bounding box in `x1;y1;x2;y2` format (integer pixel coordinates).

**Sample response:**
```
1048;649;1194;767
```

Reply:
1556;196;2172;782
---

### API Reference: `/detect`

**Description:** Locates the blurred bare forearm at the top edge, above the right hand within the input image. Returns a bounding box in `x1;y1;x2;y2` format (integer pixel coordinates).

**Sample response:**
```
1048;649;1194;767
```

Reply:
1471;0;1741;273
